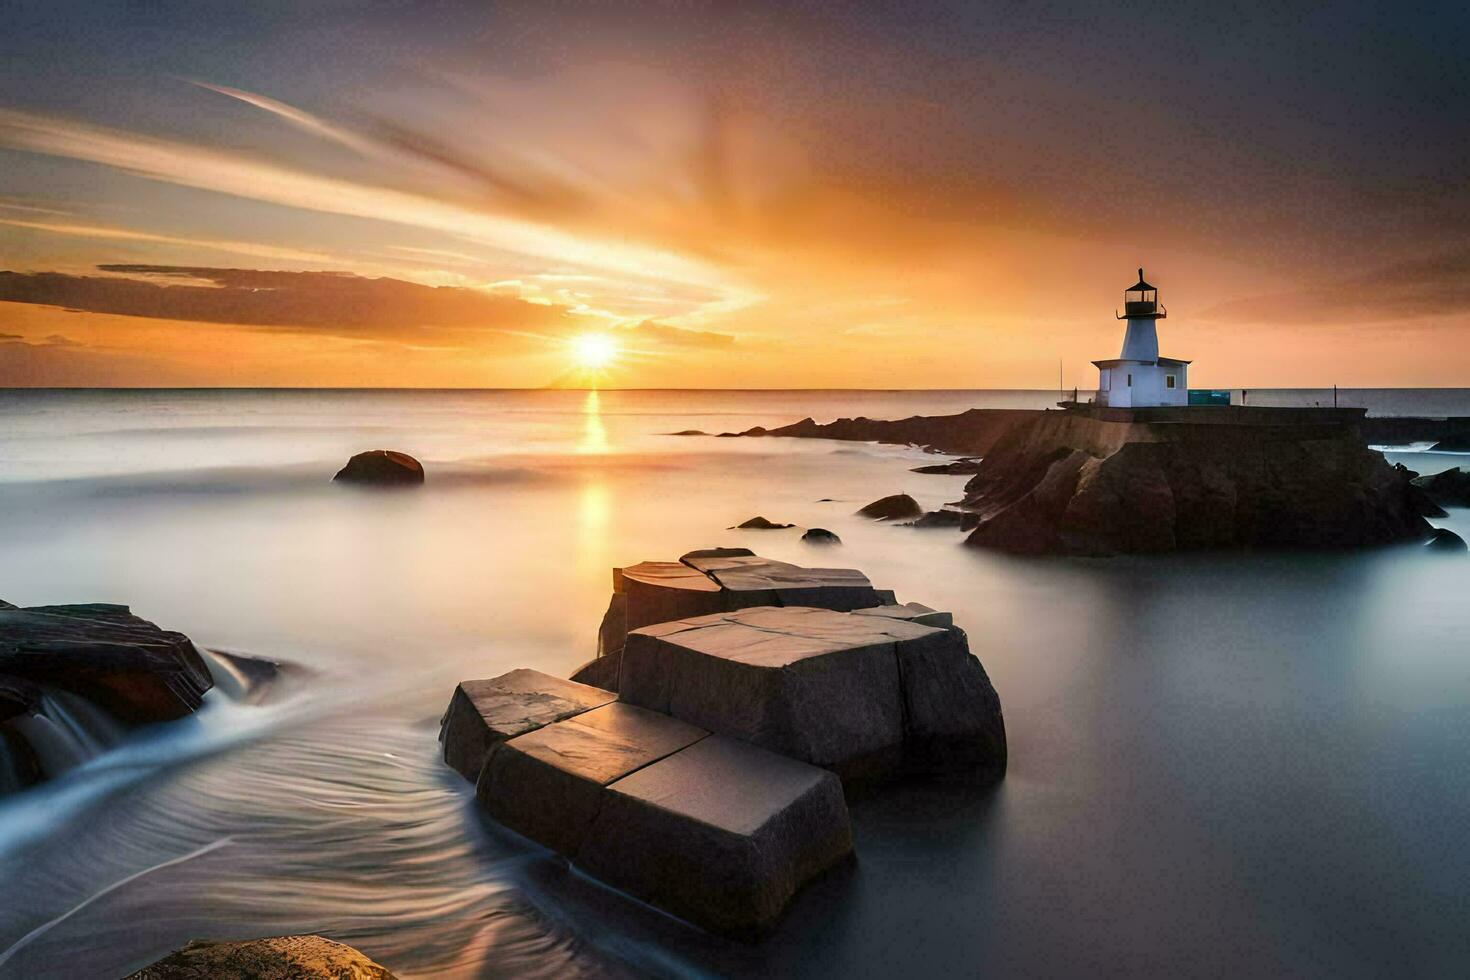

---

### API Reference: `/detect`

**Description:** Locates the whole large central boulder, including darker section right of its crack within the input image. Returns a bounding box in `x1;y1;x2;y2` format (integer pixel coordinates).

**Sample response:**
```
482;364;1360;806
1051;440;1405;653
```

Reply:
619;607;1004;782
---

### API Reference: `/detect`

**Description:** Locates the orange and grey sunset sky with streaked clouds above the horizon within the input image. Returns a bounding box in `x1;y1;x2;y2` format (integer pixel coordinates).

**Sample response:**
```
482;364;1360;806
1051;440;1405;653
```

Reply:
0;0;1470;388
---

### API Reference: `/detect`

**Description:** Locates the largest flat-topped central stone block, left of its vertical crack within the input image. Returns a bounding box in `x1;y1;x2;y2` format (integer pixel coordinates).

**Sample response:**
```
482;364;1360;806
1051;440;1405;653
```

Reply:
619;607;942;779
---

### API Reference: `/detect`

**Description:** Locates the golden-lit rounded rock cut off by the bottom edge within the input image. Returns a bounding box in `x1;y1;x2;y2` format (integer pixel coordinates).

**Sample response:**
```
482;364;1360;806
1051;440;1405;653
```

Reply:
123;936;394;980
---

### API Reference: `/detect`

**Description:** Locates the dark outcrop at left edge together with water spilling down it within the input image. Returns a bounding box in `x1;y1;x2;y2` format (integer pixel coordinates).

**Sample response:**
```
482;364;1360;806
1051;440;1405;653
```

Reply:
0;602;213;795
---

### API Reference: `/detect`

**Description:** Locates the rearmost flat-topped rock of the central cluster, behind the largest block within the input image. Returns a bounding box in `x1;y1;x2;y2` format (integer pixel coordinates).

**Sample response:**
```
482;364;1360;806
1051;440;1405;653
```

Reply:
572;552;894;691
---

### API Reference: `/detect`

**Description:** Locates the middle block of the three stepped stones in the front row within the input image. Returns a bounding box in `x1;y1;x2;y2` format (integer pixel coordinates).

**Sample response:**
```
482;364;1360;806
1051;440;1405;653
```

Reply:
475;702;709;855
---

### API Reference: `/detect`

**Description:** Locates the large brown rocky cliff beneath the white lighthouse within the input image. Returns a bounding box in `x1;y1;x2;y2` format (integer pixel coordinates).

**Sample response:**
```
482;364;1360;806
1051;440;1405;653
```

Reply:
963;411;1430;554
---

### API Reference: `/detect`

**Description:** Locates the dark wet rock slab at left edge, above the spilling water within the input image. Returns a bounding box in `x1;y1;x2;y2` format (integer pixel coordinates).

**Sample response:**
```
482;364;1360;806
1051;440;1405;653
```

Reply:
0;602;215;726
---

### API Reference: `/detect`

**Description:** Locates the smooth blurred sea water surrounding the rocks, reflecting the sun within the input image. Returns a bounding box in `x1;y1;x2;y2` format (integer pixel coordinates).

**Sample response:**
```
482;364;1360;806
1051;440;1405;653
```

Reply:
0;391;1470;977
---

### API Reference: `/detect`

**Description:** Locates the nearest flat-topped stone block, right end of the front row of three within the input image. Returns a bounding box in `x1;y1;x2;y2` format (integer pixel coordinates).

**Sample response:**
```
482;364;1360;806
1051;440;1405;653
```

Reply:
576;735;853;937
